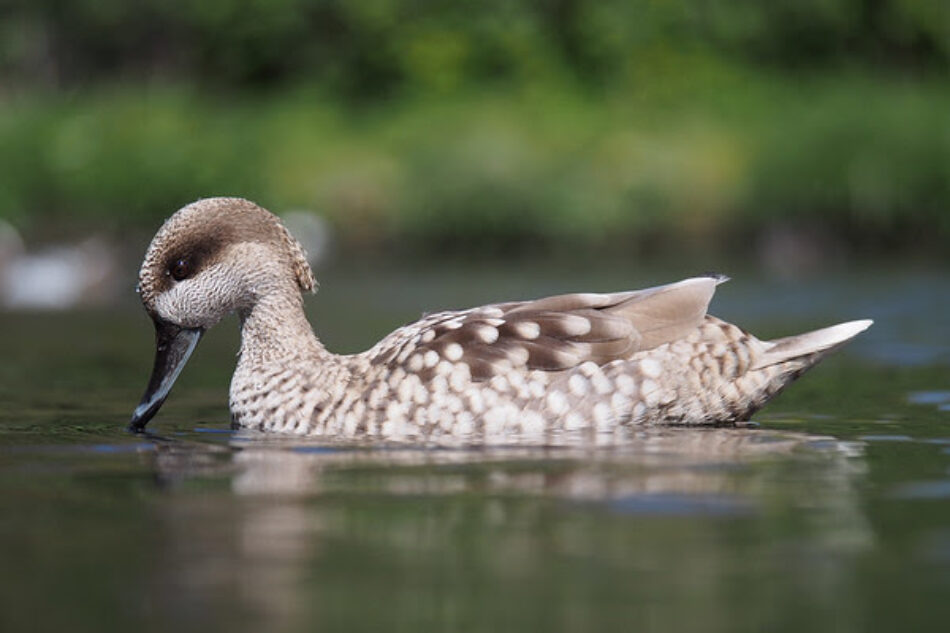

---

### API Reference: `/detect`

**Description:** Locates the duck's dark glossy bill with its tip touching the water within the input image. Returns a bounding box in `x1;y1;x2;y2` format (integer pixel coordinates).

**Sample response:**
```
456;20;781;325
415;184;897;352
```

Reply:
129;319;204;431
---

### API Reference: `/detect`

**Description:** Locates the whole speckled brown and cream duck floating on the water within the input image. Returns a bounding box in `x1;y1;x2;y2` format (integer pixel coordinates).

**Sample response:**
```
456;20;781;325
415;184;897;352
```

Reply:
130;197;872;445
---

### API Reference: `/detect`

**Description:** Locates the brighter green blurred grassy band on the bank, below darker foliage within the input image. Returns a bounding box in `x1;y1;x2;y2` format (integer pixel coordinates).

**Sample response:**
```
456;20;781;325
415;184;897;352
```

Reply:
0;70;950;250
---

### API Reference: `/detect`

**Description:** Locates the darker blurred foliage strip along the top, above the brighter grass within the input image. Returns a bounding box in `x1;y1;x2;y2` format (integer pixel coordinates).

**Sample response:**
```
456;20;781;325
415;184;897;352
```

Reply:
0;0;950;97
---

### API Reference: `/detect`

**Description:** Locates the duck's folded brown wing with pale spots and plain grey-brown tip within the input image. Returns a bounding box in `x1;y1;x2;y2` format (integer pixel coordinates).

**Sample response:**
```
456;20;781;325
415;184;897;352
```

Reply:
367;276;725;380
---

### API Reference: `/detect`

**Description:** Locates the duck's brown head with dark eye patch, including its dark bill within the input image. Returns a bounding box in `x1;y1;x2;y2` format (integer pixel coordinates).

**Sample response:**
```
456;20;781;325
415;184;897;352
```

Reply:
131;198;315;431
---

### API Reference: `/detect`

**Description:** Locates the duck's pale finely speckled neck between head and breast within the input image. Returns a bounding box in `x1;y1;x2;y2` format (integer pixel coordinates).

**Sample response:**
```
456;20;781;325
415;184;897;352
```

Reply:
238;290;330;366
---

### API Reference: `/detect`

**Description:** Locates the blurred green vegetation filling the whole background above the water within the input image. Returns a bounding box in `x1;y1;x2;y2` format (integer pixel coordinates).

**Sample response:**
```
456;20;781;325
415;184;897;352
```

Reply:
0;0;950;260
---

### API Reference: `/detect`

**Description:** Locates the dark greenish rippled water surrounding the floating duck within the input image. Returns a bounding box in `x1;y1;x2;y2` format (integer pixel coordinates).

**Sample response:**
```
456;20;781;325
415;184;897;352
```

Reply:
0;262;950;631
